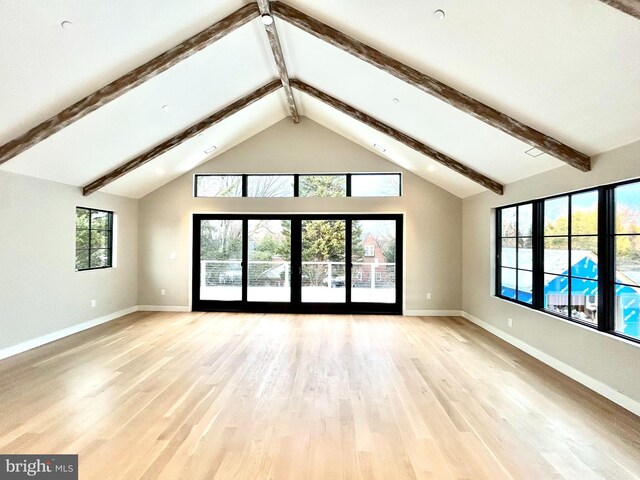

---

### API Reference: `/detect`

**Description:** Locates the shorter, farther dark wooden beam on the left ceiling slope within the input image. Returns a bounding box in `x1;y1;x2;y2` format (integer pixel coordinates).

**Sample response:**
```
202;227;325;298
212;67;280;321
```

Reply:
82;80;282;195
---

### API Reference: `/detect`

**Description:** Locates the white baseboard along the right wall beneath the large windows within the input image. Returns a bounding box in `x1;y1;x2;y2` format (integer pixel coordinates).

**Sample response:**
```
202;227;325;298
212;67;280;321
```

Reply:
461;312;640;416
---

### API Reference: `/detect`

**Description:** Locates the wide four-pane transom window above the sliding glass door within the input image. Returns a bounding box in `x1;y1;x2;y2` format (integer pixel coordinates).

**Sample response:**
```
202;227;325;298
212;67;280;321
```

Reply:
194;173;402;198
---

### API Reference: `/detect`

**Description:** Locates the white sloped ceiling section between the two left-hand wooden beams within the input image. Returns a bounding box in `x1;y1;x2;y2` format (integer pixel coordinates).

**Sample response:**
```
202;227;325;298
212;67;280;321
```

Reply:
3;20;277;196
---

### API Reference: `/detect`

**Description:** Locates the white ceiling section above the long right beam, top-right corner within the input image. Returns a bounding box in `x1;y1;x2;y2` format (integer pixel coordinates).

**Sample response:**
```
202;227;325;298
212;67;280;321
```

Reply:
287;0;640;155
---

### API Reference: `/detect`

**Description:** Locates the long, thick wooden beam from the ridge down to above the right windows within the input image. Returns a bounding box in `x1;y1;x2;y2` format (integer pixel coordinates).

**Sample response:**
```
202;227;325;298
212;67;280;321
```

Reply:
272;2;591;172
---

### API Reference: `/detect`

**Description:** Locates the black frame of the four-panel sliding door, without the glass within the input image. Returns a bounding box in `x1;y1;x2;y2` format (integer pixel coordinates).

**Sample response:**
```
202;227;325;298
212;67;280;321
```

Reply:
191;213;404;315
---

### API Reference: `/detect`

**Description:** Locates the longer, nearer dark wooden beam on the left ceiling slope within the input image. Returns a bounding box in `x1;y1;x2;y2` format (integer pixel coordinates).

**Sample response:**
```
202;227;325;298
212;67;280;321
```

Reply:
0;3;259;165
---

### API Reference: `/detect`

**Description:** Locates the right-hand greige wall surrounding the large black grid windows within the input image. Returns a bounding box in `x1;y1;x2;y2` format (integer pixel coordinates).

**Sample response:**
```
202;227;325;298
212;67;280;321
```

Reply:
462;142;640;401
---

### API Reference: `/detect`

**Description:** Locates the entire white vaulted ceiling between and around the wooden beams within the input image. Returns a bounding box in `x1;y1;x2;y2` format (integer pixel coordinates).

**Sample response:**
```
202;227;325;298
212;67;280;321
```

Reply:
0;0;640;198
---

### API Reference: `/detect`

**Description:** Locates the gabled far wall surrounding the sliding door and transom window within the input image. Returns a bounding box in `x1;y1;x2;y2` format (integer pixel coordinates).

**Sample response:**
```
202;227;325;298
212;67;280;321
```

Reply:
138;118;462;310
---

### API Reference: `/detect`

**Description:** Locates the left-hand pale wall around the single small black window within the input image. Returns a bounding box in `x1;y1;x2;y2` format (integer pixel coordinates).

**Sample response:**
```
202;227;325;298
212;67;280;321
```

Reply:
0;171;138;349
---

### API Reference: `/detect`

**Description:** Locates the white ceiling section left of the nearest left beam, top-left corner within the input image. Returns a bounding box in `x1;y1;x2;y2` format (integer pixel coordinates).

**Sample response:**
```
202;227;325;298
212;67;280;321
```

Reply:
0;0;245;144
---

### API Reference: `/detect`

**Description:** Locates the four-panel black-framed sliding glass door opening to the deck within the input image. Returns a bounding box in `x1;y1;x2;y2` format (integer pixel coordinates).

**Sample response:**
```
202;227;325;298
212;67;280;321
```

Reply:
193;214;402;313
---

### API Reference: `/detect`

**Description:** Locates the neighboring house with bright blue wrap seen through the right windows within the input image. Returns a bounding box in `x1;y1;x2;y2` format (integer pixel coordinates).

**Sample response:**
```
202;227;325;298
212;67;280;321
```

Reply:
501;248;640;337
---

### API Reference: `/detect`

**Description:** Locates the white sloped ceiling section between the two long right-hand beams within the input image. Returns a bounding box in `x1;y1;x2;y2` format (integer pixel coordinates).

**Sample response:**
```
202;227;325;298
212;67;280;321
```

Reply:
280;20;560;190
